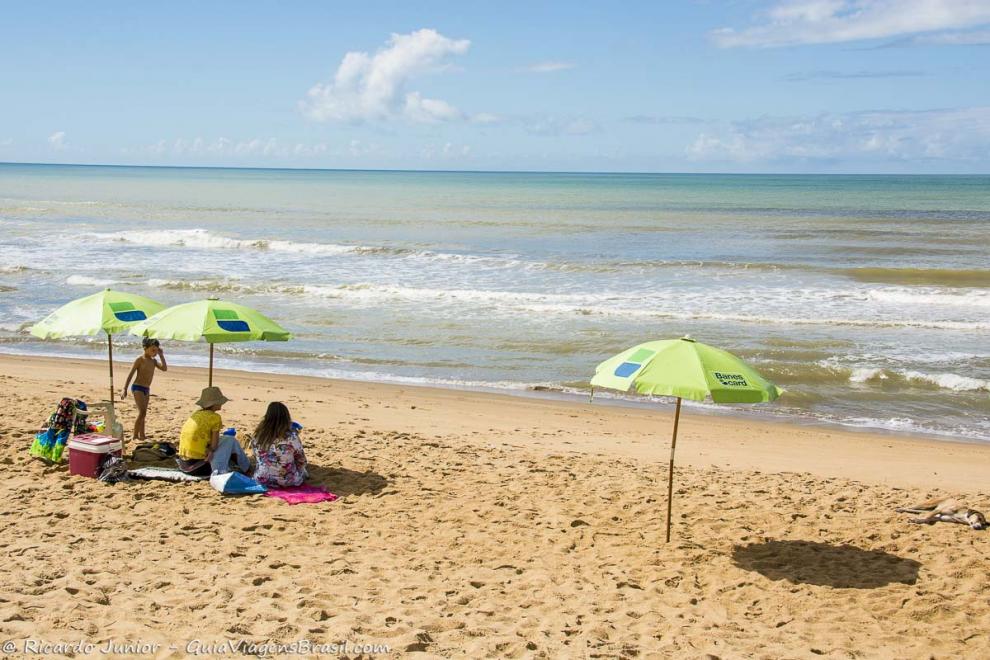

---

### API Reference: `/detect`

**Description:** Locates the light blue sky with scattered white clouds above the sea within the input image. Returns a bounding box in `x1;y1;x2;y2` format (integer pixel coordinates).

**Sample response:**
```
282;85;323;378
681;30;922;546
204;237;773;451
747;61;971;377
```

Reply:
0;0;990;173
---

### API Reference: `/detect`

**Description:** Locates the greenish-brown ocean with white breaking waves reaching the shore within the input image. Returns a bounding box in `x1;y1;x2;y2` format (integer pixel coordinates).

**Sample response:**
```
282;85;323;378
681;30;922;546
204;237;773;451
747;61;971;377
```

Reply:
0;164;990;441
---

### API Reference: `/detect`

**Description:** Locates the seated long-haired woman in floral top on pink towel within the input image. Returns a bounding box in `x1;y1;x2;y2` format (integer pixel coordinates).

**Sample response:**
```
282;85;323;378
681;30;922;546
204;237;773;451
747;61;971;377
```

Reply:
251;401;308;487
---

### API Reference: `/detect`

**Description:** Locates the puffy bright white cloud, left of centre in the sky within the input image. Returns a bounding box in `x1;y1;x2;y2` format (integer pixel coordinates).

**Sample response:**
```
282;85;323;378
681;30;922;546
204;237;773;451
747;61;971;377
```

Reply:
300;29;471;122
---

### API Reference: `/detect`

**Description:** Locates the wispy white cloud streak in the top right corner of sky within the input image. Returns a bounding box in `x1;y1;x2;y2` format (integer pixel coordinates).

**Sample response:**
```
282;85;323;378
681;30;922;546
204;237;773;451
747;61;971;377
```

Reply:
711;0;990;48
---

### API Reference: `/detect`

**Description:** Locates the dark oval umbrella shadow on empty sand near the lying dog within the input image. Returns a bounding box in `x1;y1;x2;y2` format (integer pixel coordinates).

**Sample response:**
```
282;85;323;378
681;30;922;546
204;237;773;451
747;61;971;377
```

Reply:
732;541;921;589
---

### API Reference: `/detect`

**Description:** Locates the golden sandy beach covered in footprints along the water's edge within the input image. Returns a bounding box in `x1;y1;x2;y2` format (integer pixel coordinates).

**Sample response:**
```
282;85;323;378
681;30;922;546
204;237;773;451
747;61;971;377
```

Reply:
0;356;990;658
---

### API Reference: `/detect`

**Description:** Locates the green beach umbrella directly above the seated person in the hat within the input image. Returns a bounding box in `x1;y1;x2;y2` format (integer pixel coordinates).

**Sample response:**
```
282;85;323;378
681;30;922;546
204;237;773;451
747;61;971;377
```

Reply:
130;298;292;387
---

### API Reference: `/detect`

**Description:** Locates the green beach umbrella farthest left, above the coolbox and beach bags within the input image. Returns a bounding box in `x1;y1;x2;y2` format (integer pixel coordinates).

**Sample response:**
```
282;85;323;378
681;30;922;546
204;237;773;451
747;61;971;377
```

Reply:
31;289;165;403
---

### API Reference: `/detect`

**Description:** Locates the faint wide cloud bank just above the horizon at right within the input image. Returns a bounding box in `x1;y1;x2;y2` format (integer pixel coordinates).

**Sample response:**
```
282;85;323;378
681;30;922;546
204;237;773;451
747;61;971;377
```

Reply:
686;106;990;164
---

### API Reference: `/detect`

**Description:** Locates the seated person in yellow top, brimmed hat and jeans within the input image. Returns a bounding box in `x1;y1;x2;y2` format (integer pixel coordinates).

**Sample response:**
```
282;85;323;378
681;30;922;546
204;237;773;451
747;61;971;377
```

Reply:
175;387;251;476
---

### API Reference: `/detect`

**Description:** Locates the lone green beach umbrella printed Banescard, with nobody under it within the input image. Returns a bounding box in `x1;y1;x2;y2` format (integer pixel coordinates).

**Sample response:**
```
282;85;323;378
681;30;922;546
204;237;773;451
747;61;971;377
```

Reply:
591;337;784;542
